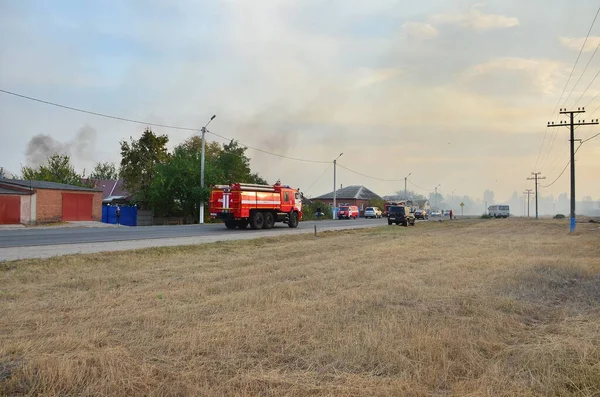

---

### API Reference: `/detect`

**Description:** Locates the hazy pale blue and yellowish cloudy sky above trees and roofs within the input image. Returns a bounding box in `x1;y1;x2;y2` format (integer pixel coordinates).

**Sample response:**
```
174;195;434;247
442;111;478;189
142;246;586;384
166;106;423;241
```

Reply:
0;0;600;200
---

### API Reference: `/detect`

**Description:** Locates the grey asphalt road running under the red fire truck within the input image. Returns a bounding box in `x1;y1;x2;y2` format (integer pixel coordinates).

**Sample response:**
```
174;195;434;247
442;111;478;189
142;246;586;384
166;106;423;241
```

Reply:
0;218;387;248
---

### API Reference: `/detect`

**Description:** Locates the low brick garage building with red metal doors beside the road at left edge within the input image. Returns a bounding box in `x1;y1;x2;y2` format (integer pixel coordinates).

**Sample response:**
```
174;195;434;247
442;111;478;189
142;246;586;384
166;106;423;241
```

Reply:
0;179;102;224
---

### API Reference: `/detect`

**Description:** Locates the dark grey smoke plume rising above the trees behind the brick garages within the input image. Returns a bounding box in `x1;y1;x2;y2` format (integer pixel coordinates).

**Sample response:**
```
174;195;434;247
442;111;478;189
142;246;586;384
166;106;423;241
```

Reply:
25;124;96;167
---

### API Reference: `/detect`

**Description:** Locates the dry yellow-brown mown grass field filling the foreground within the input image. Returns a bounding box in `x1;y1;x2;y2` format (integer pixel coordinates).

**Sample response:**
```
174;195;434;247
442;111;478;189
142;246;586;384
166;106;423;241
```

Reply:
0;219;600;396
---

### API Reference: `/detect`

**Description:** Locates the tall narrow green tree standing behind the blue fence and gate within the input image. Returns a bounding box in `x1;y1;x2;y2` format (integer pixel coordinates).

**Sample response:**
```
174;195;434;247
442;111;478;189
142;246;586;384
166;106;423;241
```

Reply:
120;128;169;208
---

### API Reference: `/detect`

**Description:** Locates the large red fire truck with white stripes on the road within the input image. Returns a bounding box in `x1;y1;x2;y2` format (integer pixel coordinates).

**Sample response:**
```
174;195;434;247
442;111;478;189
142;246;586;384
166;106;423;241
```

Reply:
208;182;302;229
